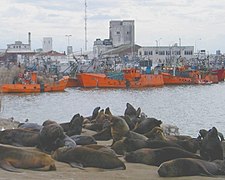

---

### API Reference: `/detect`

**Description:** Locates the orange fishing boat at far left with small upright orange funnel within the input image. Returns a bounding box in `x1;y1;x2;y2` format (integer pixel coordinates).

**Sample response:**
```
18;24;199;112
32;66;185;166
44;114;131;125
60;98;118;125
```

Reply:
1;72;69;93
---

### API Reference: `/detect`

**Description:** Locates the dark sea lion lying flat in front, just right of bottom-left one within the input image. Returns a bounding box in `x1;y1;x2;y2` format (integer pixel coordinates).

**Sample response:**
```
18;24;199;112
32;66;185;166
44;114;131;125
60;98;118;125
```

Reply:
52;147;126;169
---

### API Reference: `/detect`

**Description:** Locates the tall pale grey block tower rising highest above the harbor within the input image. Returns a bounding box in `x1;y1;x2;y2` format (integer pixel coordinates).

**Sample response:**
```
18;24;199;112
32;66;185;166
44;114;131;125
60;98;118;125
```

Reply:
109;20;135;47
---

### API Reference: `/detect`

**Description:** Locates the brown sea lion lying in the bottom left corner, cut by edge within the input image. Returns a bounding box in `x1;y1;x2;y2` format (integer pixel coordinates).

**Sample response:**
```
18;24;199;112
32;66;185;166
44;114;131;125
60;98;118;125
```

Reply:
0;144;56;172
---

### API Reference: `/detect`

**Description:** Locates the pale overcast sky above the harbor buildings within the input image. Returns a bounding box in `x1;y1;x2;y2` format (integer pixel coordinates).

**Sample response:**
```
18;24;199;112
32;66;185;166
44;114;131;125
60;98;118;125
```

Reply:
0;0;225;53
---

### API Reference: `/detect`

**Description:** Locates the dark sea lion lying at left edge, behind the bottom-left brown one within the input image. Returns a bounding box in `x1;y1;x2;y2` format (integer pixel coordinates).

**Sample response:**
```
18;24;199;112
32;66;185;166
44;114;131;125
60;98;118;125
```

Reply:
0;128;40;147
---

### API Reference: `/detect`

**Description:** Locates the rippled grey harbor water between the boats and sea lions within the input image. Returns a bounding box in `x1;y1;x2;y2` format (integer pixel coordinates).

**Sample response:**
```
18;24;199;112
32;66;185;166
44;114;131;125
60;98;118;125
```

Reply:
1;82;225;137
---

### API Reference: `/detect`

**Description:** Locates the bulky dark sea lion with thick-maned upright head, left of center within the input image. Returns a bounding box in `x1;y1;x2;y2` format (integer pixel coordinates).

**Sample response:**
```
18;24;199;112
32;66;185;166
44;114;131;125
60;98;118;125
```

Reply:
38;123;66;153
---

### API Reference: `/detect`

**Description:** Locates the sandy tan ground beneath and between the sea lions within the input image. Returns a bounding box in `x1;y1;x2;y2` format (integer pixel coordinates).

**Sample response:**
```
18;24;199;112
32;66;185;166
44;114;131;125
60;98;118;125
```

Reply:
0;118;225;180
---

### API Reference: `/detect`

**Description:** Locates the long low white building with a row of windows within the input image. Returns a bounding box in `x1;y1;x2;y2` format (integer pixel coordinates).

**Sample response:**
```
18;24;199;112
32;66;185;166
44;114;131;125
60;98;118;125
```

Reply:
138;44;194;66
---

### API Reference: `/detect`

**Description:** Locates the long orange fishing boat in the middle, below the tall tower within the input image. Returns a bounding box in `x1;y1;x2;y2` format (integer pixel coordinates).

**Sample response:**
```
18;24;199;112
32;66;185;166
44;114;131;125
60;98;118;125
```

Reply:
77;68;164;88
